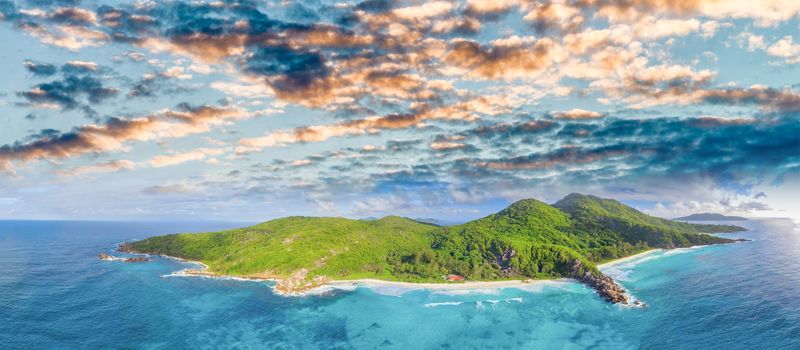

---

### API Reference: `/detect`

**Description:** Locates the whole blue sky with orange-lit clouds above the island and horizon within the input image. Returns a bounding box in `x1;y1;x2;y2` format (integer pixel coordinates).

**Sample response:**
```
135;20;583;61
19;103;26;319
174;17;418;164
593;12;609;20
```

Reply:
0;0;800;222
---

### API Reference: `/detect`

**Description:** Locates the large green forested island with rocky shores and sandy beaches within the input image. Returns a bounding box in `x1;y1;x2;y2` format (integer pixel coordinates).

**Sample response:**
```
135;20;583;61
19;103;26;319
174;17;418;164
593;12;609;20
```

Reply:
119;193;745;304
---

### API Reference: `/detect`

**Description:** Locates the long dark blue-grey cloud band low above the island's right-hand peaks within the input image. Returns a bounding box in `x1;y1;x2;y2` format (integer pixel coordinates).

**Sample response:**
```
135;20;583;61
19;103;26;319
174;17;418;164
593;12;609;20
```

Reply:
296;114;800;204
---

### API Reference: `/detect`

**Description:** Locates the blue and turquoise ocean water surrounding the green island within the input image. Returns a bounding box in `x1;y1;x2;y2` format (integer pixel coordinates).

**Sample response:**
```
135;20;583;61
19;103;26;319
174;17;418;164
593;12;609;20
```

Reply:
0;219;800;349
